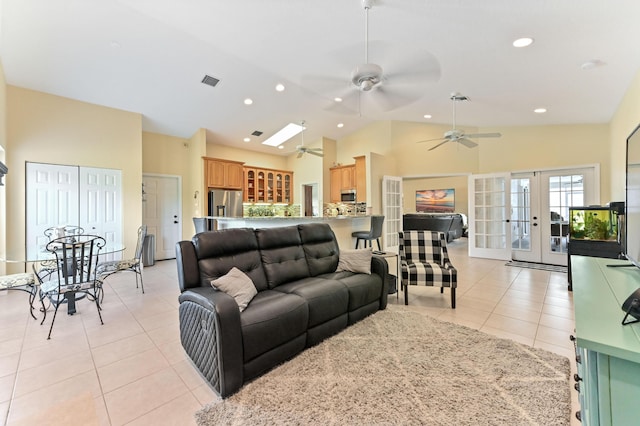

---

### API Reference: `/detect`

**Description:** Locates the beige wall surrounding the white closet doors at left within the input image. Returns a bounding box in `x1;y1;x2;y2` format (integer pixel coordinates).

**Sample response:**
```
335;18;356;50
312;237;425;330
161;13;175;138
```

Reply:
6;86;142;258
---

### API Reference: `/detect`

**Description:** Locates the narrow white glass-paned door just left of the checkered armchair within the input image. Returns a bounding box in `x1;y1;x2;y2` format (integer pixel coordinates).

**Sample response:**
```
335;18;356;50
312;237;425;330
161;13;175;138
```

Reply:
382;176;402;253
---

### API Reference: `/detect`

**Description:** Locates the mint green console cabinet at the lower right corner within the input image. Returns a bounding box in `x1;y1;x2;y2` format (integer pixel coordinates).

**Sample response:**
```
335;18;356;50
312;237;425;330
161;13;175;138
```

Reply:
571;256;640;426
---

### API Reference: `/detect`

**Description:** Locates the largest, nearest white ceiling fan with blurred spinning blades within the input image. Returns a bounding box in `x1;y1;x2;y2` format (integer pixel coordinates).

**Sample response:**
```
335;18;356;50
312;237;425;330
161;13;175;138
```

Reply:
310;0;440;113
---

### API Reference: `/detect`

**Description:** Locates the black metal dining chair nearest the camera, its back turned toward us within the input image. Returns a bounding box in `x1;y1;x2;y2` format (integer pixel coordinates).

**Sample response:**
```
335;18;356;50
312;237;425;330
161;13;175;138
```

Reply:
38;235;106;339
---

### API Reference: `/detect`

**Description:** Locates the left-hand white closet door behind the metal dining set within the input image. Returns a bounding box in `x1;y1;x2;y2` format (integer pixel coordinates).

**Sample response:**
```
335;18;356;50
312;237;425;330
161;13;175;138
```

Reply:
26;163;80;259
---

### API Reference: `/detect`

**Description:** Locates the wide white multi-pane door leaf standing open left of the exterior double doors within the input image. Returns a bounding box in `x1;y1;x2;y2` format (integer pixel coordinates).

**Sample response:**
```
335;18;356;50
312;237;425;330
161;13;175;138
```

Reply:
469;173;511;260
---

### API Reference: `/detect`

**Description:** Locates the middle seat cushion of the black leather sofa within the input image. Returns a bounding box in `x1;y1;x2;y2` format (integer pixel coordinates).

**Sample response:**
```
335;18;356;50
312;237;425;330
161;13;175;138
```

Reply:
274;277;349;327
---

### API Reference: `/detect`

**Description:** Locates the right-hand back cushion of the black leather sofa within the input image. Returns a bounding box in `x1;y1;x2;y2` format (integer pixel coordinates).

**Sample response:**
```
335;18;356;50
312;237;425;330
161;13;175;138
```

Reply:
298;223;339;277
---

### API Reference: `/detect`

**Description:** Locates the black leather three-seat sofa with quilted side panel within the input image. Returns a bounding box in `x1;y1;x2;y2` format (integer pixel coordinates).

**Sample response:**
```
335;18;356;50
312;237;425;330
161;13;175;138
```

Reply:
176;223;388;398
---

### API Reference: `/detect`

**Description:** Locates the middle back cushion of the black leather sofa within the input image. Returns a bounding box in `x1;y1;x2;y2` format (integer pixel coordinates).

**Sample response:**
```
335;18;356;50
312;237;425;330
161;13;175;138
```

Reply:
255;226;309;288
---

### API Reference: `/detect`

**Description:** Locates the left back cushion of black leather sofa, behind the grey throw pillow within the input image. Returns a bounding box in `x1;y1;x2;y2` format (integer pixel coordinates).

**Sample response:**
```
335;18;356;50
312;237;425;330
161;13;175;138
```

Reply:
191;228;268;291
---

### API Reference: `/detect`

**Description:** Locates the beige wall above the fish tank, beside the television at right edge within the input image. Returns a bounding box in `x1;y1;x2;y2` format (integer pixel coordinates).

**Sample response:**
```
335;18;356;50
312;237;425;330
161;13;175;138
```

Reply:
609;71;640;200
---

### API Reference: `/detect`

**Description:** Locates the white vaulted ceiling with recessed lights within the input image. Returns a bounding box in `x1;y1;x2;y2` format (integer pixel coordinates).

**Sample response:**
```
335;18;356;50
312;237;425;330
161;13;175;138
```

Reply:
0;0;640;154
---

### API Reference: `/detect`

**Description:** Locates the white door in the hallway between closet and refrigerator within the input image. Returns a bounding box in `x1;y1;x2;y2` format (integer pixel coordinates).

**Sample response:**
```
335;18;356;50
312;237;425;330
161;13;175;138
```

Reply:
142;175;182;260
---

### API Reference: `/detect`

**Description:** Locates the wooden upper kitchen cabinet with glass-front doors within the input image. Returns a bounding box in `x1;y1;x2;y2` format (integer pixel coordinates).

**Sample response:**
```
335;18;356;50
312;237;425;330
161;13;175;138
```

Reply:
243;166;293;204
